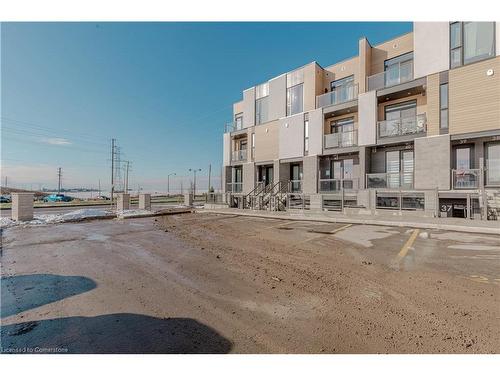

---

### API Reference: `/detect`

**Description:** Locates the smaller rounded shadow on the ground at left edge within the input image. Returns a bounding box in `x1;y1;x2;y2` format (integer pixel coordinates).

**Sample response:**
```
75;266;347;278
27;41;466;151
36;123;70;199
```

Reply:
1;274;97;318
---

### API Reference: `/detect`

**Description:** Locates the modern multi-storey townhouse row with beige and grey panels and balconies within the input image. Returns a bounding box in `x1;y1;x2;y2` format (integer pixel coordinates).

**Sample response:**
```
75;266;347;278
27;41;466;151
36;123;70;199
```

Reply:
223;22;500;218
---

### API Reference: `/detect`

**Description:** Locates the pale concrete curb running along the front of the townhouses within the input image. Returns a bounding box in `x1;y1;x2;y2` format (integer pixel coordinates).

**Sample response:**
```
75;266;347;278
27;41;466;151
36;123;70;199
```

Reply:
196;209;500;235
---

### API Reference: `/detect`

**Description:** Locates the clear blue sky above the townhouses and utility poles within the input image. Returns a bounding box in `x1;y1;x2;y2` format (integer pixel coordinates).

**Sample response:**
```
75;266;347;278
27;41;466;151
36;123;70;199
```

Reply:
0;22;412;192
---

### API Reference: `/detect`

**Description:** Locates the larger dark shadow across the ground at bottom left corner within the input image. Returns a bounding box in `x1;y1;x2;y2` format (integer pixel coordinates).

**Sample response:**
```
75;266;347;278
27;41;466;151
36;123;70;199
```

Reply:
1;314;232;354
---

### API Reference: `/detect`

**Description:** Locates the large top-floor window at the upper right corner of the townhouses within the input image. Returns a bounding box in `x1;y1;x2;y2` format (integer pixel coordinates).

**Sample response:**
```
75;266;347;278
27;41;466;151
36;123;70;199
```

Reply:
450;22;495;68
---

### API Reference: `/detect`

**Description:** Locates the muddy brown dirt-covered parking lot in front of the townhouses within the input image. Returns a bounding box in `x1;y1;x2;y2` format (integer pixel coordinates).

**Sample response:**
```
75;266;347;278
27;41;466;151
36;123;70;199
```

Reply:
1;213;500;353
